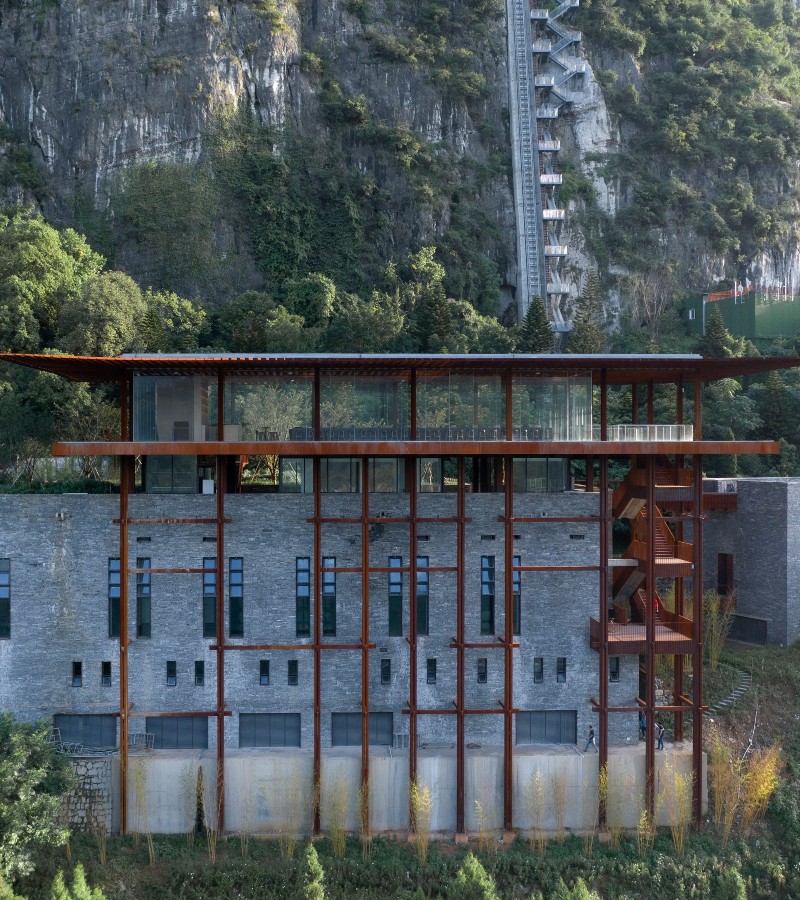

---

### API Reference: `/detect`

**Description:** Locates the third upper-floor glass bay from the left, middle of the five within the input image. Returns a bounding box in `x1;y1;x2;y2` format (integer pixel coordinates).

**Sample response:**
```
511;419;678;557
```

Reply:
320;372;411;441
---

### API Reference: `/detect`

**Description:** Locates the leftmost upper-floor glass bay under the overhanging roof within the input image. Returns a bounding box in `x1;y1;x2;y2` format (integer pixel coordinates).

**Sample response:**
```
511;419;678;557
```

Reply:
133;375;217;441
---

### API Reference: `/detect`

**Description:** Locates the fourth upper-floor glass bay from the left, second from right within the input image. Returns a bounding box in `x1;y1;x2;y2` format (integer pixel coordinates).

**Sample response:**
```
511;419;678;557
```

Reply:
417;374;506;441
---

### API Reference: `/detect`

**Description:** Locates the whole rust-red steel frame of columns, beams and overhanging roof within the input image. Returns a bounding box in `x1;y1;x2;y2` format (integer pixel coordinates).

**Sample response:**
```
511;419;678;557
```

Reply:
0;354;800;833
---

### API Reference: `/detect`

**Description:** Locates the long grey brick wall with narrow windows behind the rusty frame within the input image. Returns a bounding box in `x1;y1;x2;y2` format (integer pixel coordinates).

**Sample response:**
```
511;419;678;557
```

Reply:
0;493;638;748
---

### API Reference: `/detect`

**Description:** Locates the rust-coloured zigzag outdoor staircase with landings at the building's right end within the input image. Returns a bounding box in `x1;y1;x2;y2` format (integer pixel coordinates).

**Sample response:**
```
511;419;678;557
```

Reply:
590;460;693;655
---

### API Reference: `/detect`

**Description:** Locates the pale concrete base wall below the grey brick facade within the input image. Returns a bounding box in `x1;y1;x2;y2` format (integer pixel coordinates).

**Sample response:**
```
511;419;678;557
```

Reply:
114;747;707;834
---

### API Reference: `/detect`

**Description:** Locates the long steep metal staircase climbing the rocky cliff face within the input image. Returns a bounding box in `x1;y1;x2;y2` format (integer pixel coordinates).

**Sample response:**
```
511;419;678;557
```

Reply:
507;0;586;332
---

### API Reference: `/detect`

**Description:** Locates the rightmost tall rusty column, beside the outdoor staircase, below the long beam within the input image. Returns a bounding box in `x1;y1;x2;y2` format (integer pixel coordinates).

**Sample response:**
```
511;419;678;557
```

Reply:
692;456;703;825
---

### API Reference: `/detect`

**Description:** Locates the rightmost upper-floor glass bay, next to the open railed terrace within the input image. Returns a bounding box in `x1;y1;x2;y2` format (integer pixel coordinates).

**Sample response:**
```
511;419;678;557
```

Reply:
512;375;592;441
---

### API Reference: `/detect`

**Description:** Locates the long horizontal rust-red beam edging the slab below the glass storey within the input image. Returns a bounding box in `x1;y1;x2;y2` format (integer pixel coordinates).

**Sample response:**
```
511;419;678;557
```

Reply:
52;440;780;457
